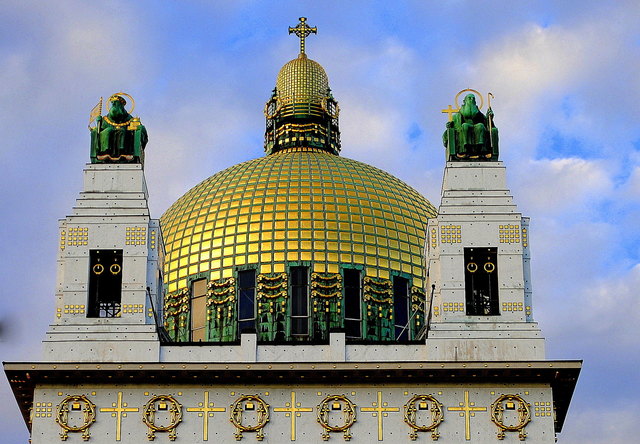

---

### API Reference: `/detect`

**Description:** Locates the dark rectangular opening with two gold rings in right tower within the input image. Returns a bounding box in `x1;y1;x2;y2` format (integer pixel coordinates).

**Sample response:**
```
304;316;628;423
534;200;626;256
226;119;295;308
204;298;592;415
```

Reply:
464;247;500;316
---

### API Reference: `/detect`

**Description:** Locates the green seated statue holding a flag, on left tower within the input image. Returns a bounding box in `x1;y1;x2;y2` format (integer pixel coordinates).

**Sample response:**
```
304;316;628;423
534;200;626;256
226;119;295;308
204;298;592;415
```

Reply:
89;93;148;163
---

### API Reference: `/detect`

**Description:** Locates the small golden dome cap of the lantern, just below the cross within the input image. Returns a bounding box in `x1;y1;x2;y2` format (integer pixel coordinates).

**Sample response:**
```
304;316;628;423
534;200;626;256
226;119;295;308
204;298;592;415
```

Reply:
276;54;329;104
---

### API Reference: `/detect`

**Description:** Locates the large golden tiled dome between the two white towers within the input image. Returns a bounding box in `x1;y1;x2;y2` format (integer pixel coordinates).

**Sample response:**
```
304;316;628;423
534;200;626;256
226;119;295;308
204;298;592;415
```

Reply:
161;148;436;292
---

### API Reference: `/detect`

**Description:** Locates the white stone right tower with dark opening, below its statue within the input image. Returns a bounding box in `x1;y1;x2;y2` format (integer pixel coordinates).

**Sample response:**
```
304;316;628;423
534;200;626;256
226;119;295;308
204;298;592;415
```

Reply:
427;160;544;361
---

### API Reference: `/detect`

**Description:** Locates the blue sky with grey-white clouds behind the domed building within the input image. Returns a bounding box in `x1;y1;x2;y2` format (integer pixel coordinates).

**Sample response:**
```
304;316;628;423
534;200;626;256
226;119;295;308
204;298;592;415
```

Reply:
0;0;640;444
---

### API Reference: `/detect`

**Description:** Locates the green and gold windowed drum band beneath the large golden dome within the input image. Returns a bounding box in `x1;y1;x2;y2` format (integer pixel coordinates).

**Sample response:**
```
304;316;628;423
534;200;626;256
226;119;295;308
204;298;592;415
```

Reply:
165;262;425;344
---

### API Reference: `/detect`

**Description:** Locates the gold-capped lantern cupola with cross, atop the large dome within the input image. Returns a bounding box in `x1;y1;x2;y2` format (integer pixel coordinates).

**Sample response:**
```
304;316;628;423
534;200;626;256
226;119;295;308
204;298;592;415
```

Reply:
264;17;340;154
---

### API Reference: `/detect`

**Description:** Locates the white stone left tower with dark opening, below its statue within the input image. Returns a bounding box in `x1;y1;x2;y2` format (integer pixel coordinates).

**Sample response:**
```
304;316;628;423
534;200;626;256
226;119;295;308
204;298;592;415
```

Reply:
43;163;163;362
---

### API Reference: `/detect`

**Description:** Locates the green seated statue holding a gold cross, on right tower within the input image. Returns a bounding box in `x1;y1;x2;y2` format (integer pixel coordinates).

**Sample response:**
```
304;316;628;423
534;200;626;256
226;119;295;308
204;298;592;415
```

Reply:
442;94;499;160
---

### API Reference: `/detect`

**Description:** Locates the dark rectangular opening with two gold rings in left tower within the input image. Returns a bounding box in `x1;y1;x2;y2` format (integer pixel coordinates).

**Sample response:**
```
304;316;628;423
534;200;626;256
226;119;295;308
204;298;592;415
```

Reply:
87;250;122;318
